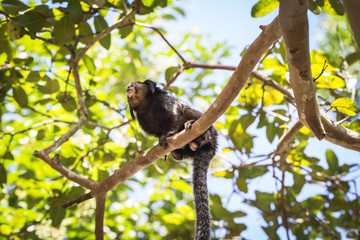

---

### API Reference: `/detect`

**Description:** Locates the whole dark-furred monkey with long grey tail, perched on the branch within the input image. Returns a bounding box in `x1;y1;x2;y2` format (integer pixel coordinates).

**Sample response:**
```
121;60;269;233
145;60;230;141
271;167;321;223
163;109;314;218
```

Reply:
126;80;217;240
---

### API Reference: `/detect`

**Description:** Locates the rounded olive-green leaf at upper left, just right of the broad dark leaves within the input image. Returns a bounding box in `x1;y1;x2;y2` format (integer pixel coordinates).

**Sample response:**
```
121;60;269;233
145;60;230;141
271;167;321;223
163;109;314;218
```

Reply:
54;15;75;44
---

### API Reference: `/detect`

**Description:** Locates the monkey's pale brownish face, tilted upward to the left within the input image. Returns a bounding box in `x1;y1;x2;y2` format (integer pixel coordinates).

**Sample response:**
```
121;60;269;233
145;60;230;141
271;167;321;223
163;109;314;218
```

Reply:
126;82;149;110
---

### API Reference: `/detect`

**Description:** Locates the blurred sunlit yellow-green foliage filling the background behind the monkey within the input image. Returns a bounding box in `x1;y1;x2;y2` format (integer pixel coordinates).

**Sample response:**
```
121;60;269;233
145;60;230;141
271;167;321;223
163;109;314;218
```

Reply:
0;0;360;239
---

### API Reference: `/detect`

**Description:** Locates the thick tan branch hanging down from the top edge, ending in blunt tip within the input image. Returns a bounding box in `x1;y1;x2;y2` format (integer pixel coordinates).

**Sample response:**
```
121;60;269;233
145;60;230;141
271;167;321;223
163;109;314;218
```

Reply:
279;0;325;140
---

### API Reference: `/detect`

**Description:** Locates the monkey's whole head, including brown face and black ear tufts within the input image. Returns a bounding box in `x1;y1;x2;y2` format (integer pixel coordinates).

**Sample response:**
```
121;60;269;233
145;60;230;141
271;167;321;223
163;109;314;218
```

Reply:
126;80;156;119
